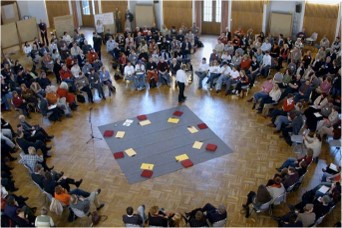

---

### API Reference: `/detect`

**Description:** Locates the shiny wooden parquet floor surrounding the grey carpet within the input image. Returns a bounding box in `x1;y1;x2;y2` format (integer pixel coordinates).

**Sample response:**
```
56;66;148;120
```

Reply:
3;31;341;227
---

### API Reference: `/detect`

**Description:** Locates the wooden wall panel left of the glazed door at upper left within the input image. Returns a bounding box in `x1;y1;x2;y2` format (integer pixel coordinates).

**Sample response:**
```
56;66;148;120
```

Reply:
45;0;70;28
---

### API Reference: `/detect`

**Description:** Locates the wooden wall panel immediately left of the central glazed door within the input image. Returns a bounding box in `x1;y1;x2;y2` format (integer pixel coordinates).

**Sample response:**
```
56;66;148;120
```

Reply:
163;1;192;28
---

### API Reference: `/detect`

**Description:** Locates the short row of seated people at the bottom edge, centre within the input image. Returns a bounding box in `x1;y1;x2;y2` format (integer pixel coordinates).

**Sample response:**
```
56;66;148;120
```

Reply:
122;203;228;227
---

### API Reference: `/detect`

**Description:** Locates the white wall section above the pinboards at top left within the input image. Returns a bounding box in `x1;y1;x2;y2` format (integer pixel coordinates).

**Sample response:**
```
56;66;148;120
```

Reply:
17;0;50;27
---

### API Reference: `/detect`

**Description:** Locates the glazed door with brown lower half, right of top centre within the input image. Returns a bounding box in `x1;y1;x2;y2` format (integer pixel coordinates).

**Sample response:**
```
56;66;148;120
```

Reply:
202;0;222;35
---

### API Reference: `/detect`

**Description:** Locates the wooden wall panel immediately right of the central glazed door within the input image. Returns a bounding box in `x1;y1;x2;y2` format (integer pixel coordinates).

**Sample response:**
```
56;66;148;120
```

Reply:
231;0;264;33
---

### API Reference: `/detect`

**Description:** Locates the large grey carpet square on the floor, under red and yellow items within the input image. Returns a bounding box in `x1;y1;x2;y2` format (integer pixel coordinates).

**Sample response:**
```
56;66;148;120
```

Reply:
99;105;232;184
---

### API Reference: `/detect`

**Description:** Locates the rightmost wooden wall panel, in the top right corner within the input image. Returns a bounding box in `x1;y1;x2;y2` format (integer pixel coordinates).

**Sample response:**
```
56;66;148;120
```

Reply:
303;3;338;43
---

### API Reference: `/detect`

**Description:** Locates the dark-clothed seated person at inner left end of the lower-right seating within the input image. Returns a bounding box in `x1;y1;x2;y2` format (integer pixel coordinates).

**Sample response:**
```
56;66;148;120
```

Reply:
242;185;272;218
